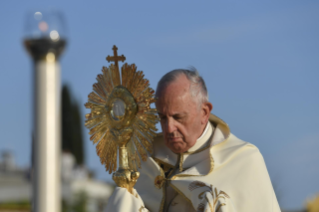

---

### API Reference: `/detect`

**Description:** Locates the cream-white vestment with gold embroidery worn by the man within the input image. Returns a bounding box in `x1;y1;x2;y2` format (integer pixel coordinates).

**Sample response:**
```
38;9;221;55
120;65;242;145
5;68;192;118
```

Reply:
107;115;280;212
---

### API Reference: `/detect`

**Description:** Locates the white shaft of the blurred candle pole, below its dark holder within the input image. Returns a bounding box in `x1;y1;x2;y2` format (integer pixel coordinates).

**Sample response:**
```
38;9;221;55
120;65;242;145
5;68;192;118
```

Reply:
33;52;61;212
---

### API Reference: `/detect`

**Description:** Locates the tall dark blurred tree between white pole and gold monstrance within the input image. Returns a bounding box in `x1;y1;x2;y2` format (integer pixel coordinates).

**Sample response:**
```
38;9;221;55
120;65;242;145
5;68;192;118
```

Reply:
62;85;85;165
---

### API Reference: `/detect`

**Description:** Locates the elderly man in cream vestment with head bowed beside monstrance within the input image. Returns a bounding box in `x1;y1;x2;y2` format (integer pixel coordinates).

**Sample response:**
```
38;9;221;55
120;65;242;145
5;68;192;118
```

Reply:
107;69;280;212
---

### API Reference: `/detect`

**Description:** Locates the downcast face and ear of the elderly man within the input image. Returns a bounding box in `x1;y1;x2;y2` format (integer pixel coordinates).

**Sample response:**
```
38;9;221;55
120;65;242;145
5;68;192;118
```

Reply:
156;75;212;153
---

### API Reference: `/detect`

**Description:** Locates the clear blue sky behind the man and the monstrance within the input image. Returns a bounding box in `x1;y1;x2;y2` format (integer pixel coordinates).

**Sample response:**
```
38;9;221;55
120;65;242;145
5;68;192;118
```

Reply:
0;0;319;208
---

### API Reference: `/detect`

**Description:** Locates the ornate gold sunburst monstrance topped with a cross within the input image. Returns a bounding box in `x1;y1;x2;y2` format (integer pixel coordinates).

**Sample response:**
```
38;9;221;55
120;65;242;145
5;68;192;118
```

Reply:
85;46;158;193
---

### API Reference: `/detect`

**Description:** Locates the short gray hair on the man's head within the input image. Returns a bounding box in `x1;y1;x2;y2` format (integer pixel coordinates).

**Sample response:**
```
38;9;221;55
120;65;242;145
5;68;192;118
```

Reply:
155;67;208;103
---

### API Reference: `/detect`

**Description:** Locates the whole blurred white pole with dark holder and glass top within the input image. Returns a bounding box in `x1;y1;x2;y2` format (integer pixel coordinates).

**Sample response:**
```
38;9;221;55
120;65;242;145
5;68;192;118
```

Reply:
24;11;66;212
